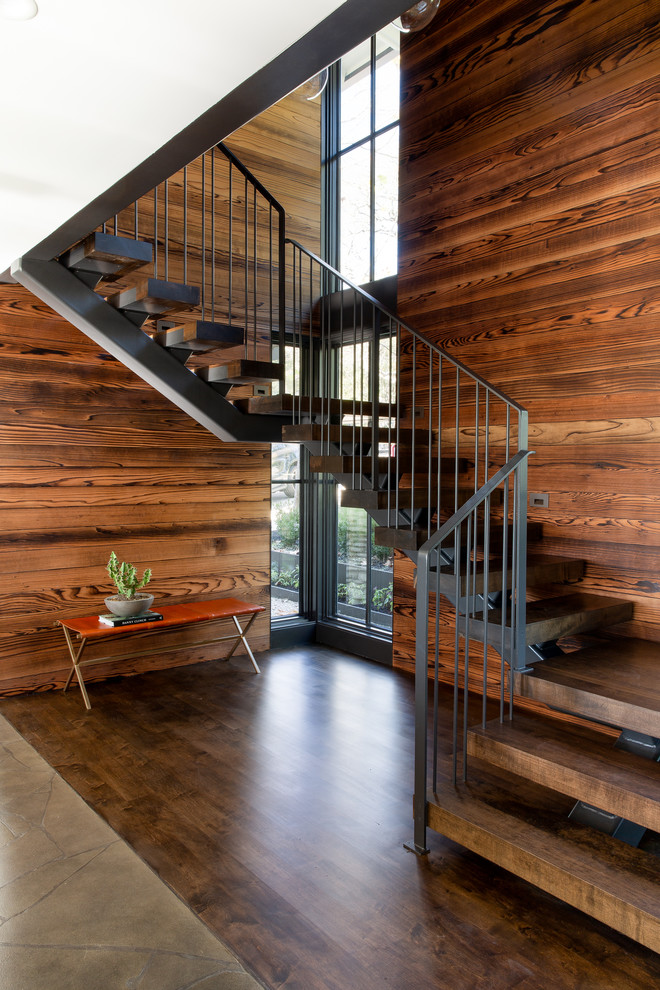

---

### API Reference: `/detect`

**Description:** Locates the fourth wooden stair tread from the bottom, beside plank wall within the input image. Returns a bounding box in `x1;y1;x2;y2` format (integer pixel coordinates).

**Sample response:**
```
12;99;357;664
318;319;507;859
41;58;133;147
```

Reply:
470;592;633;646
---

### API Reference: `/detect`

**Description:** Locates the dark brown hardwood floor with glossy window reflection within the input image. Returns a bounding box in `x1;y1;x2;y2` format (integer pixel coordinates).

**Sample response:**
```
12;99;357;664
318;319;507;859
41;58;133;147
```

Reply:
0;647;660;990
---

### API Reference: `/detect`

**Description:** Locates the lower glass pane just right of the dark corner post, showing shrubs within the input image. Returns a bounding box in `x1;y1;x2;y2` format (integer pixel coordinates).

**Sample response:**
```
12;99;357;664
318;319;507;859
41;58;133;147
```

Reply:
336;505;369;623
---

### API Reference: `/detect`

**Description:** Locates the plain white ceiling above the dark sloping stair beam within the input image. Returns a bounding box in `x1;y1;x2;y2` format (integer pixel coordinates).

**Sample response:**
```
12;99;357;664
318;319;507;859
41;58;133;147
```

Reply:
0;0;350;272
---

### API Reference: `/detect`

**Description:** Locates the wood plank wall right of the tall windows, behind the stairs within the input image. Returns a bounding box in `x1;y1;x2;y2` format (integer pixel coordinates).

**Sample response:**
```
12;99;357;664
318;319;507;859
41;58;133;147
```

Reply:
394;0;660;680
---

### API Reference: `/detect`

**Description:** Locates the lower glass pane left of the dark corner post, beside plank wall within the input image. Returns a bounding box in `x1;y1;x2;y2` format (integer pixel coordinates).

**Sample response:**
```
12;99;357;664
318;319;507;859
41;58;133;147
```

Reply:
270;480;300;619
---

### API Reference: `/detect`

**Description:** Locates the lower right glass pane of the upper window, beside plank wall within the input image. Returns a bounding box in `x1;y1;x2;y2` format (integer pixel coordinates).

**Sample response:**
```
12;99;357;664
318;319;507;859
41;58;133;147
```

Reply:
374;127;399;278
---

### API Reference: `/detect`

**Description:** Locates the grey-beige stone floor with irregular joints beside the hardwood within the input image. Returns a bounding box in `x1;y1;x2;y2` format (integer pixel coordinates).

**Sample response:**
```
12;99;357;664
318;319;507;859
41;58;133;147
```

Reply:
0;717;261;990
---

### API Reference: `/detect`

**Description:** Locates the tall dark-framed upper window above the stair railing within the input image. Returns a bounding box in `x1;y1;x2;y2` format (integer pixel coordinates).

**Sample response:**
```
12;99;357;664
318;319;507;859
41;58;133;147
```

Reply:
324;25;399;285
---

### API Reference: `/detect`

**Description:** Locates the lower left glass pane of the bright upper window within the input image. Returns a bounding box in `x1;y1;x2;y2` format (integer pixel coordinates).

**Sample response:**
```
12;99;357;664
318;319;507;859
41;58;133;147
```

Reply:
339;144;371;285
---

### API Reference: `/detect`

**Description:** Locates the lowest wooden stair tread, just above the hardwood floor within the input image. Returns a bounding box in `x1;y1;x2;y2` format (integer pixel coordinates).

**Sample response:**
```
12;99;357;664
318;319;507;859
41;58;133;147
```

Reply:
428;761;660;952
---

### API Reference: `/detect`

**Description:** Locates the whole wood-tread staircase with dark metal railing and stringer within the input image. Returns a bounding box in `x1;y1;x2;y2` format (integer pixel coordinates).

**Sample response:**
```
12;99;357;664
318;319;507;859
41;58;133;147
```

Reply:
13;145;660;951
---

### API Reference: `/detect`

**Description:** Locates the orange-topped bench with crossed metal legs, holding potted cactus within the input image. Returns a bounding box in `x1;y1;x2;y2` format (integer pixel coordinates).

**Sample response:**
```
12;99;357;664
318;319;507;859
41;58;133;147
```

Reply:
57;598;265;709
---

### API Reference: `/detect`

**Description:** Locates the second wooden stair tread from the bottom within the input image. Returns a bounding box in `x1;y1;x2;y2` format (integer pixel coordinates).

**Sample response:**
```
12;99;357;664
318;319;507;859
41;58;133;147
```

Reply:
468;714;660;832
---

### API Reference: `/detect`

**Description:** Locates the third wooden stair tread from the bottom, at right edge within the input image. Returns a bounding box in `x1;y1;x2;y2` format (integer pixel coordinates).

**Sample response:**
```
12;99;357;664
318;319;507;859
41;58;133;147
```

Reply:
514;637;660;737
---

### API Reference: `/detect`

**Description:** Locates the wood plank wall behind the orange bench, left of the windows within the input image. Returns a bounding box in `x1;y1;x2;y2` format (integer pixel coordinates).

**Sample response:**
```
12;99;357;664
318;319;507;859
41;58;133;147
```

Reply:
0;96;320;695
